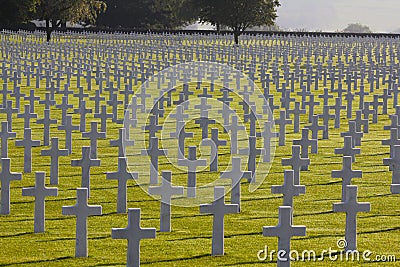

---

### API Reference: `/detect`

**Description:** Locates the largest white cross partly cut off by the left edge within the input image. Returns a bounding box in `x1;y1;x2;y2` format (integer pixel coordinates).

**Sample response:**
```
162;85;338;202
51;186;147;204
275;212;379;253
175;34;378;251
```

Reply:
0;158;22;215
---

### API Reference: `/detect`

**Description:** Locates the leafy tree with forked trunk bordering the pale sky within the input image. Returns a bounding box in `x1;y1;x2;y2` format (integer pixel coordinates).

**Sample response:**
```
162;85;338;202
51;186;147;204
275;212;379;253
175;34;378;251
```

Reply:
193;0;280;44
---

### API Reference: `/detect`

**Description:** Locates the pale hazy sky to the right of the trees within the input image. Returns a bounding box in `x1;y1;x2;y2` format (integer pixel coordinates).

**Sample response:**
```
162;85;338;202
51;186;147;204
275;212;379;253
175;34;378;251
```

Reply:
277;0;400;32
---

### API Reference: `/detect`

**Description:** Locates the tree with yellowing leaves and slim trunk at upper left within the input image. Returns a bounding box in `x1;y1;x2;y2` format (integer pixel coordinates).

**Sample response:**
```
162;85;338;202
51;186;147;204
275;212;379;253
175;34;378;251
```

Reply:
35;0;106;42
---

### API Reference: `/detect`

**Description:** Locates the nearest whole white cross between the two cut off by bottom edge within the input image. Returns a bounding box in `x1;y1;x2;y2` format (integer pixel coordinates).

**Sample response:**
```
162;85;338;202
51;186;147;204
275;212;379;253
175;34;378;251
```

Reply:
200;186;239;256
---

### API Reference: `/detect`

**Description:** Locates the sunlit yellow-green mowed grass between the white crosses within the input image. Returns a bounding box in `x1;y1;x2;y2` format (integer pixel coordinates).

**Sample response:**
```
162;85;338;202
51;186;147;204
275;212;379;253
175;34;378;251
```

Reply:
0;32;400;266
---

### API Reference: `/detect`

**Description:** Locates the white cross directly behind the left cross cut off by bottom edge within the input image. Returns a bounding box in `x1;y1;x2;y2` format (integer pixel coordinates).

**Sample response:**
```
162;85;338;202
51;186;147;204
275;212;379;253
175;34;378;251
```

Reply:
107;157;139;213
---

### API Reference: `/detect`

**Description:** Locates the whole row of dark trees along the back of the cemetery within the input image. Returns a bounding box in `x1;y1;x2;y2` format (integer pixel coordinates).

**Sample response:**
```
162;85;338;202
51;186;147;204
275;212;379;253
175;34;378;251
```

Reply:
0;0;280;43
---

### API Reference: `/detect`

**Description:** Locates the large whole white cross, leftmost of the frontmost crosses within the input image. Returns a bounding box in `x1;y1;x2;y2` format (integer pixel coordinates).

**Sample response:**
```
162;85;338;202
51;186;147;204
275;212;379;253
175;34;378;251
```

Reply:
62;188;102;258
